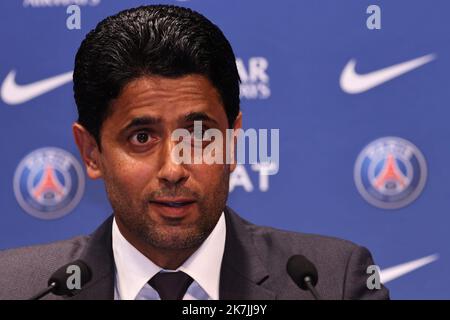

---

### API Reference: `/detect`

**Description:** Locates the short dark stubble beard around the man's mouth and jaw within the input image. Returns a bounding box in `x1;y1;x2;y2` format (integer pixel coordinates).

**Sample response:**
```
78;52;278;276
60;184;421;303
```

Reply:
108;169;229;250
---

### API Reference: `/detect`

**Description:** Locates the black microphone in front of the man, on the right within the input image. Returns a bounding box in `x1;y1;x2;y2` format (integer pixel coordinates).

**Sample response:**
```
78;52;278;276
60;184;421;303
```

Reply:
286;254;322;300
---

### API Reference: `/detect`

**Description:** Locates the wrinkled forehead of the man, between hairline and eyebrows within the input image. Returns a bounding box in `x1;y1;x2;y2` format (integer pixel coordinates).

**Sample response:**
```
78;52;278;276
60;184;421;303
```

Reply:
108;75;227;125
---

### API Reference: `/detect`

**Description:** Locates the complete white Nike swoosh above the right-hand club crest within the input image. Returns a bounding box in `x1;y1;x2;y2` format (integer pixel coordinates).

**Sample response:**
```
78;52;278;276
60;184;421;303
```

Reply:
339;54;436;94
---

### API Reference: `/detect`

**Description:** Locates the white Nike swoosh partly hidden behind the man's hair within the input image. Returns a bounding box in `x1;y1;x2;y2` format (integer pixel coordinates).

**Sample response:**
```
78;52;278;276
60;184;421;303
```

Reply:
0;70;72;105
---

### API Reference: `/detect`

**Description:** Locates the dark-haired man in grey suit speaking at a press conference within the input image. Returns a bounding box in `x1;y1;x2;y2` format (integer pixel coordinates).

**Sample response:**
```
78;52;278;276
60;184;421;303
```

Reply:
0;6;388;300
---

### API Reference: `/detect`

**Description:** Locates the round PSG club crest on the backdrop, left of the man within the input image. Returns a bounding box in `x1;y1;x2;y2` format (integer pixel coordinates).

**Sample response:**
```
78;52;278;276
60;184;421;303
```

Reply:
13;147;84;219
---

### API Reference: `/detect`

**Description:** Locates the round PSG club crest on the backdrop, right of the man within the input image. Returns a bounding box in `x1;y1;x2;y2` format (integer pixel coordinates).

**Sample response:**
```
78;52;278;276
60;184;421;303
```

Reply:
354;137;427;209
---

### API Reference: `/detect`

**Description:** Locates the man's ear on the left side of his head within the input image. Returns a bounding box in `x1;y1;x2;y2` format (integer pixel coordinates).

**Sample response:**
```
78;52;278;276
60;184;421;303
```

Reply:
72;122;102;179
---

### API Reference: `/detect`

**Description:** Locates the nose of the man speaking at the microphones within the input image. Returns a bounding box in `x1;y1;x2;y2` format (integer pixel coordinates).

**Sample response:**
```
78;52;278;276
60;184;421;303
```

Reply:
158;141;189;185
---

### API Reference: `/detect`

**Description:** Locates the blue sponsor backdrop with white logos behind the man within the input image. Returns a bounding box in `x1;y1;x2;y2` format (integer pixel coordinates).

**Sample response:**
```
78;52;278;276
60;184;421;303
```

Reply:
0;0;450;299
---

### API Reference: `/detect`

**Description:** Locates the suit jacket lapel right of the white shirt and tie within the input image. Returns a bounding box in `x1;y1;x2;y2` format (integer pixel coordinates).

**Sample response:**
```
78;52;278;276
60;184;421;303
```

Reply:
219;207;276;300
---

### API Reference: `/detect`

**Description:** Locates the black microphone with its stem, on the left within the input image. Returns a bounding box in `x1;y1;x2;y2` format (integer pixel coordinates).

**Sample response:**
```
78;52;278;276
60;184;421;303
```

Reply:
29;260;92;300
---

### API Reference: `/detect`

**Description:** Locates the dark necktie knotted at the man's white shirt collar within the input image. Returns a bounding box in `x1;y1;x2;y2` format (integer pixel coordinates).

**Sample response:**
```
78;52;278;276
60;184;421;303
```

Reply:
148;271;193;300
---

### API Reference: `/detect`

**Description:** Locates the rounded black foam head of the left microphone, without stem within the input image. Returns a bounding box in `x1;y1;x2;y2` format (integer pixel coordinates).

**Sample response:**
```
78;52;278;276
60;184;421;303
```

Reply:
48;260;92;296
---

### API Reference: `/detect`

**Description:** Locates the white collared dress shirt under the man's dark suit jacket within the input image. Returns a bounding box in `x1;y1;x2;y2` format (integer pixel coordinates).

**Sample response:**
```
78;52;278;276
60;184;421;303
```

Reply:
112;212;226;300
